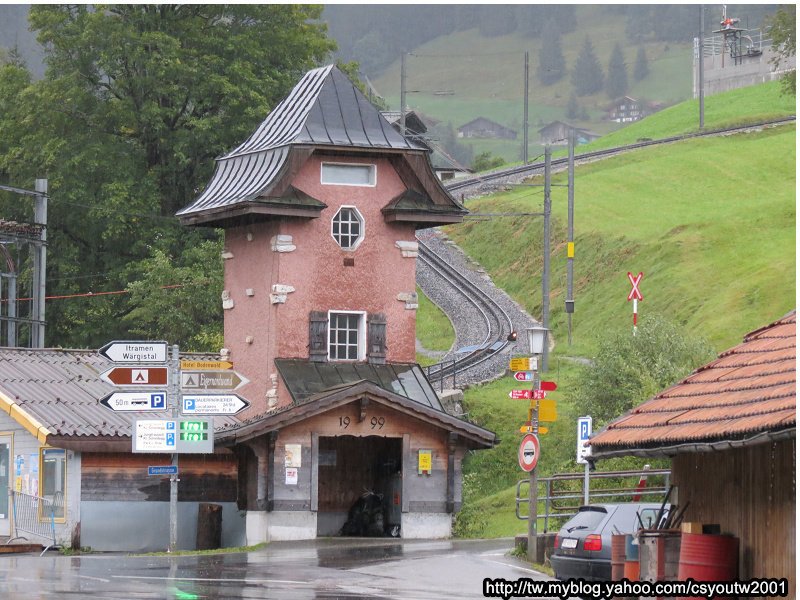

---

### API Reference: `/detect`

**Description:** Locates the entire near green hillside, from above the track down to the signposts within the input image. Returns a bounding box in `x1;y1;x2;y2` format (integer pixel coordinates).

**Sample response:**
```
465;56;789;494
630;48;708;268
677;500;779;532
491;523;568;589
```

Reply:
434;85;796;536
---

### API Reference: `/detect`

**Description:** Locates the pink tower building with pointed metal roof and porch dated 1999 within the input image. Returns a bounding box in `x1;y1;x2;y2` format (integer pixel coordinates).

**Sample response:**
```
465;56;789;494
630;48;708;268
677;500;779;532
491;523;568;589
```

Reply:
178;65;495;543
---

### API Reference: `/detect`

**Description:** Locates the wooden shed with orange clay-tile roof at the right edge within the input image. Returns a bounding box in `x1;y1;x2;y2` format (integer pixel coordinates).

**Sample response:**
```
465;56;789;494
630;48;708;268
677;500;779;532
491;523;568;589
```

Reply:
588;311;797;598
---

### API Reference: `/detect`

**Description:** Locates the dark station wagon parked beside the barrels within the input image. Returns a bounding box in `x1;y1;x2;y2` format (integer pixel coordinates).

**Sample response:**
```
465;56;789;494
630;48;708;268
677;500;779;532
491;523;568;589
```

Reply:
550;502;669;581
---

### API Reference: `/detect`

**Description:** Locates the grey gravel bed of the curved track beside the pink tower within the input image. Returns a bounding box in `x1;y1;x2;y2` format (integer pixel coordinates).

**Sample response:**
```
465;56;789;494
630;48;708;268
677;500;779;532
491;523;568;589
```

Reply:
417;228;536;389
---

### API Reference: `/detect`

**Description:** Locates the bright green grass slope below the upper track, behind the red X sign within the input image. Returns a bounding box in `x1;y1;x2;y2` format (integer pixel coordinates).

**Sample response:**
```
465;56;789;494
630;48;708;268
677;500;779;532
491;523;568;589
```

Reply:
447;86;796;356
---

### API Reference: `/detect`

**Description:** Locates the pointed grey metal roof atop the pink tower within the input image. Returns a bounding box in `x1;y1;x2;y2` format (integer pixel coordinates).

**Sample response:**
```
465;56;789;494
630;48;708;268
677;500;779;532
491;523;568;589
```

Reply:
177;65;440;223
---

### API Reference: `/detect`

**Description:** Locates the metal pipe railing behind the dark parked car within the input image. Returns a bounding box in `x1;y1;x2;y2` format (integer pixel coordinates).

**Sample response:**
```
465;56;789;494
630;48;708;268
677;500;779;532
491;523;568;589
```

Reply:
516;469;670;532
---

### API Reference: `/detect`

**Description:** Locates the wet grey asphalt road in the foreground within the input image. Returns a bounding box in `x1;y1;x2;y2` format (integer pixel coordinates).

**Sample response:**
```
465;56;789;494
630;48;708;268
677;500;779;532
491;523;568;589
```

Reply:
0;539;547;600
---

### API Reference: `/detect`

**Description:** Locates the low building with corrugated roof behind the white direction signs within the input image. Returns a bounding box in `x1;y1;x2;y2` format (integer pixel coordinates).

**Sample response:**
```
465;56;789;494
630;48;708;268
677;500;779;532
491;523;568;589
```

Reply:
0;348;245;552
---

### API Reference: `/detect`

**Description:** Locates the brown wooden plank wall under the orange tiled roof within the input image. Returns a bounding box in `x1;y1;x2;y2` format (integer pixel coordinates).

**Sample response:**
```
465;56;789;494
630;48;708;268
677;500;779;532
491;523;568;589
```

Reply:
672;439;796;598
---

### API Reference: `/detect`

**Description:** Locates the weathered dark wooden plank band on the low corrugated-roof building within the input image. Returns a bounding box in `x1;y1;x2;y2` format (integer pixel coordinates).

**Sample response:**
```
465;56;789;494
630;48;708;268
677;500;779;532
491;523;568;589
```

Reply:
81;453;237;502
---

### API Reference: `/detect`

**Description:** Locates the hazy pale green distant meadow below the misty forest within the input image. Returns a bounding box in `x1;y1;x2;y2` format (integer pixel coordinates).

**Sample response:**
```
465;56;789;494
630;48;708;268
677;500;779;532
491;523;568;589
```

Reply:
373;5;692;161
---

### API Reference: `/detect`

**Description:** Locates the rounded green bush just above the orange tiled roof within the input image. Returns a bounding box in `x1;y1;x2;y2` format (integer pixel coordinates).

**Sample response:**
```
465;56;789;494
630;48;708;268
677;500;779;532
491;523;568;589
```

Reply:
570;315;714;425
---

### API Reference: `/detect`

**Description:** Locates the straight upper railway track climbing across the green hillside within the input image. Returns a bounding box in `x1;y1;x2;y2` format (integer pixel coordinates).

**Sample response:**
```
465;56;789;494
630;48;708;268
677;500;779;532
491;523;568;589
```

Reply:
445;116;795;198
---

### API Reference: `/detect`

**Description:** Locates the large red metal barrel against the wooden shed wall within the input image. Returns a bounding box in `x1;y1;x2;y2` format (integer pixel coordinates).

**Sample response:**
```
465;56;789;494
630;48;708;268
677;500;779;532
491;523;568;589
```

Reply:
678;533;739;596
